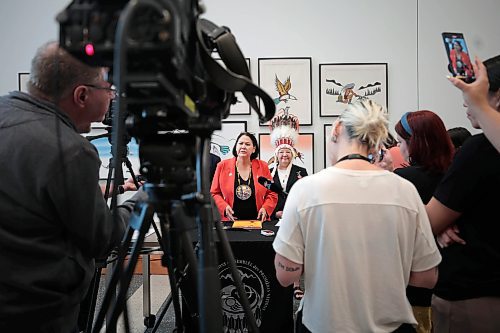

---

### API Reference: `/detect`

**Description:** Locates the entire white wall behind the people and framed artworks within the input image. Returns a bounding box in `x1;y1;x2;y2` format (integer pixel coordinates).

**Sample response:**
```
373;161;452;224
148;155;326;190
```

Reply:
0;0;500;171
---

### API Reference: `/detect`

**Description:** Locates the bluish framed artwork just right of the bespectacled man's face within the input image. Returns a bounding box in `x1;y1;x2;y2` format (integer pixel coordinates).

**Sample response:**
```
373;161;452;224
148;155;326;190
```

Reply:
88;128;140;180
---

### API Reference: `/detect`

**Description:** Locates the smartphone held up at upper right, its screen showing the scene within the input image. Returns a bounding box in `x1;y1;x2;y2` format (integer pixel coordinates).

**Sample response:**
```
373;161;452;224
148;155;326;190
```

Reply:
442;32;476;83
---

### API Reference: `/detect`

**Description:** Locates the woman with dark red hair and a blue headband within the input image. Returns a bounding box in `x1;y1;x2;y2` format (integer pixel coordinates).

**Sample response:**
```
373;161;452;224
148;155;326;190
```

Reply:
394;110;454;332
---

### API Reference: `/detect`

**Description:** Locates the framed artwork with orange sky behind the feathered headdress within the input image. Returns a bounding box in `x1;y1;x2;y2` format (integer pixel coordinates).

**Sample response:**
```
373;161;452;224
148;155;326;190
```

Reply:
259;133;314;175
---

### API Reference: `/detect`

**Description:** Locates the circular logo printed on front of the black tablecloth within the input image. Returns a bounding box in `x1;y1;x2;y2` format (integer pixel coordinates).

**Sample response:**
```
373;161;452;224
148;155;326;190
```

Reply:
219;260;271;333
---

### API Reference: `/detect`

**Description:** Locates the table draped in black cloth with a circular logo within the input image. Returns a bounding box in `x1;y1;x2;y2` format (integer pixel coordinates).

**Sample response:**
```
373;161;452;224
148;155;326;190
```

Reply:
217;222;293;332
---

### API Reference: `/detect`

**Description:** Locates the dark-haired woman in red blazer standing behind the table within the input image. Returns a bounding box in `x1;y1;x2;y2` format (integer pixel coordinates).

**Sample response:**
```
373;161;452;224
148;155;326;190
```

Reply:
210;132;278;221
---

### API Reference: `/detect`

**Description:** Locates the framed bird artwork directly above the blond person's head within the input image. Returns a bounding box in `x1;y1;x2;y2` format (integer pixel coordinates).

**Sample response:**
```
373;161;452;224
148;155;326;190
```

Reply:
319;63;387;117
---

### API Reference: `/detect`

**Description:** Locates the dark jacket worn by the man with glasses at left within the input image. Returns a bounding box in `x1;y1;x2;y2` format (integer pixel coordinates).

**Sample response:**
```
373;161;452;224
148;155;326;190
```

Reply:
0;92;143;327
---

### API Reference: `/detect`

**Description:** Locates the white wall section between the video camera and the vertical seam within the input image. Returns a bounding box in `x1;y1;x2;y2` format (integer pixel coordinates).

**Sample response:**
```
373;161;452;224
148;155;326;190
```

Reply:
205;0;417;172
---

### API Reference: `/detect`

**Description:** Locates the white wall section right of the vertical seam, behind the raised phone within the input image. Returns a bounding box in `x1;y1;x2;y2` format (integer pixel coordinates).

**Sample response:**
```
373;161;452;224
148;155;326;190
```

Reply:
418;0;500;133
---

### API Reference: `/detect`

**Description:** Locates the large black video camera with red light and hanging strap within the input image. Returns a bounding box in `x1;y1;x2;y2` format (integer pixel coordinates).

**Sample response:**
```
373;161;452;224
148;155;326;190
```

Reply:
57;0;275;187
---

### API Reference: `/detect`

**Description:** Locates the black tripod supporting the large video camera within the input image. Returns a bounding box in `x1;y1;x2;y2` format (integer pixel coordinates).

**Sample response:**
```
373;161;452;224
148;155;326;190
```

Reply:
92;134;258;333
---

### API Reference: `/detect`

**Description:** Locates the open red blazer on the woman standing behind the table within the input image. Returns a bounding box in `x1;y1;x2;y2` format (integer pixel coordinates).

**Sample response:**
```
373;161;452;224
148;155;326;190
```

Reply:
210;157;278;220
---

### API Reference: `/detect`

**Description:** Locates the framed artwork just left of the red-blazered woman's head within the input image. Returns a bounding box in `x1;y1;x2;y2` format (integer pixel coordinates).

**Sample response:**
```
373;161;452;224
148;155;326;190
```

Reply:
210;121;247;160
